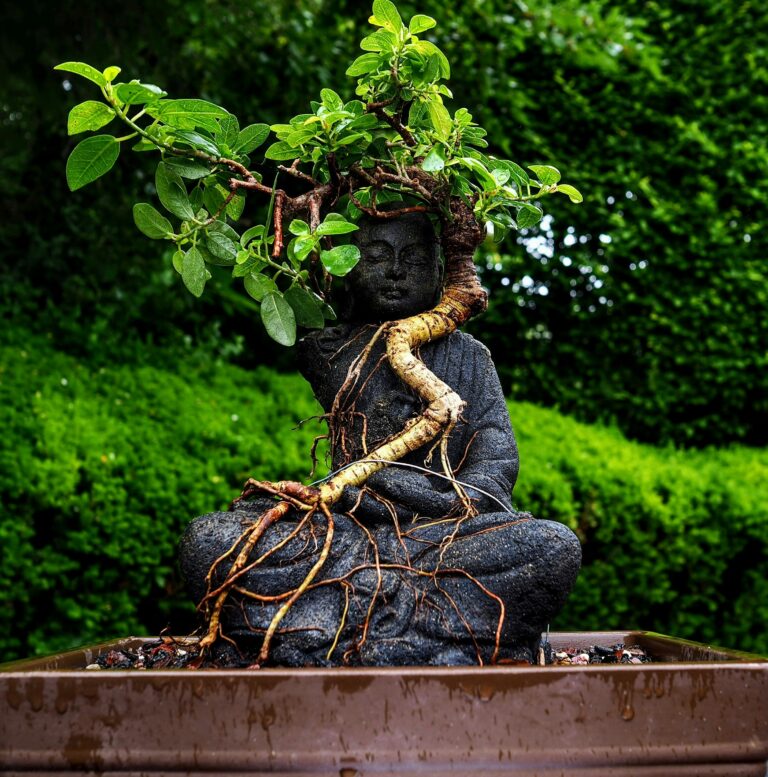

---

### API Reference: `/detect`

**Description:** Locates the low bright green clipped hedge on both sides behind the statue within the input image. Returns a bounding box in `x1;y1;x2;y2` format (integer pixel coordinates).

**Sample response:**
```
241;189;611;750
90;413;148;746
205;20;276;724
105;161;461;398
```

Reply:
0;331;768;659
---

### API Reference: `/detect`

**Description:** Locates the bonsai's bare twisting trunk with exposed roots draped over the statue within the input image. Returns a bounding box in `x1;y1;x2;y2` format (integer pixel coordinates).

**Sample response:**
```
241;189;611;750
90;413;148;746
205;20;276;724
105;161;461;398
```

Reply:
190;194;505;665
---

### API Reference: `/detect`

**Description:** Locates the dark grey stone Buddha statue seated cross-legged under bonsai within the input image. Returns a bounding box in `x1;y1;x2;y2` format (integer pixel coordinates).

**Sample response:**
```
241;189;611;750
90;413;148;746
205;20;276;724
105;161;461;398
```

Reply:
180;214;581;666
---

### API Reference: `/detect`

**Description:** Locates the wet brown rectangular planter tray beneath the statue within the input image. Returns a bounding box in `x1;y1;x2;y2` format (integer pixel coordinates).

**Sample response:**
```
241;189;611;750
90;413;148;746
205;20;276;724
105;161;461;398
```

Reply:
0;631;768;777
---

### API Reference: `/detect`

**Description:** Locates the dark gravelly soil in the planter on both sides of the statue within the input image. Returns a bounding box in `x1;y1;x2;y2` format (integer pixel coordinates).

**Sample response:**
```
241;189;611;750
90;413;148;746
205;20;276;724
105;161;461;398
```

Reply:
85;637;657;670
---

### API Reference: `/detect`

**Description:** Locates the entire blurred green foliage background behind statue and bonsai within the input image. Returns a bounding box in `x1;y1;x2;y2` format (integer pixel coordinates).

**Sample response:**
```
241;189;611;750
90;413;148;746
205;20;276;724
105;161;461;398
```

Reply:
0;0;768;659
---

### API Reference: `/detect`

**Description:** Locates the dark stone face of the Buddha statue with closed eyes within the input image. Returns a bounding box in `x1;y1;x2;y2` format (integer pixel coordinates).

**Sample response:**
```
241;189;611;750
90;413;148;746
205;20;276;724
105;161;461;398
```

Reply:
347;214;440;323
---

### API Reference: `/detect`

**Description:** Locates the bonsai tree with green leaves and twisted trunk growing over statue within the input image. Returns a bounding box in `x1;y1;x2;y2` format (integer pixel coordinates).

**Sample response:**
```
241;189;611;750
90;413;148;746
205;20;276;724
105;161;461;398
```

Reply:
57;0;582;661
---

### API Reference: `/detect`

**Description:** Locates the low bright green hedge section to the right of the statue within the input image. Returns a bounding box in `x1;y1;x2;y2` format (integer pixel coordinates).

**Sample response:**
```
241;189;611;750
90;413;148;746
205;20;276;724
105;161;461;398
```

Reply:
510;403;768;653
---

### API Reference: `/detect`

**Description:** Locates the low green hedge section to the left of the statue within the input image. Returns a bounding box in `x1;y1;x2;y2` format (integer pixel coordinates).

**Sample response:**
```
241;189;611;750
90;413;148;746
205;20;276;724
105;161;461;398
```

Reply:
0;324;319;658
